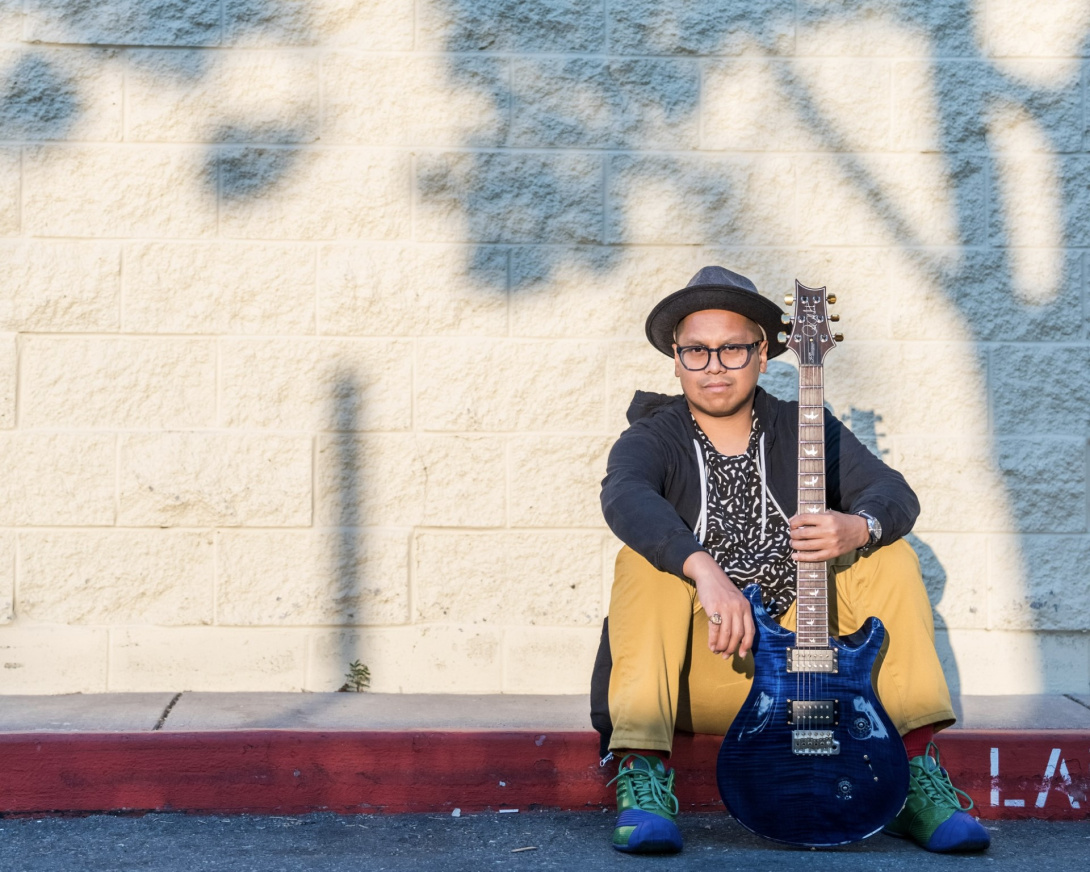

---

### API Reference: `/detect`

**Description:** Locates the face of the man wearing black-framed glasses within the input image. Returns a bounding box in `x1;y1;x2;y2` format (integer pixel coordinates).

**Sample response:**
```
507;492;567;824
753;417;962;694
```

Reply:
674;308;768;417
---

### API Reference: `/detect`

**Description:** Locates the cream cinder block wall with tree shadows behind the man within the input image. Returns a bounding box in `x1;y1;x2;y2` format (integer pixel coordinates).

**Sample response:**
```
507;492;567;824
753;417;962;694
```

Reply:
0;0;1090;693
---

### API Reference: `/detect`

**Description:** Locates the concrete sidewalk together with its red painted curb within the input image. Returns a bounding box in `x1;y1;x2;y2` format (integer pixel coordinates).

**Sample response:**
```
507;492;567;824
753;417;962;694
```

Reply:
0;693;1090;820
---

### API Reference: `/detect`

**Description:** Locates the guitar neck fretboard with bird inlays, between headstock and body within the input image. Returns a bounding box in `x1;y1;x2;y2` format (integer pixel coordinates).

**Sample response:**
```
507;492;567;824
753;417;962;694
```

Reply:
796;364;829;647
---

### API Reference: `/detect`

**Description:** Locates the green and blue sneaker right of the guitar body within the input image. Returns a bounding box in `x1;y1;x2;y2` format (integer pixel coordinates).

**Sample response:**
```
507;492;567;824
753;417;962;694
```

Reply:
885;742;992;853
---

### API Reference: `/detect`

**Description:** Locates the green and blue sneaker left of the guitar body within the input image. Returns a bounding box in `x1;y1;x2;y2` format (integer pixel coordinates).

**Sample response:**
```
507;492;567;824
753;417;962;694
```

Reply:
609;754;681;853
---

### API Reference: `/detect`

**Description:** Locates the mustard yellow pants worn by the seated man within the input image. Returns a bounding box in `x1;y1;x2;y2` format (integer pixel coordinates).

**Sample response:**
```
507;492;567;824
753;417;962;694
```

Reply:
609;540;955;753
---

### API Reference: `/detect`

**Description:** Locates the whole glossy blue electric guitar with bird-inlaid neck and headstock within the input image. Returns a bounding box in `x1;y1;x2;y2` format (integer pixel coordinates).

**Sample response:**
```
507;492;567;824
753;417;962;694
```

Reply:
716;281;908;847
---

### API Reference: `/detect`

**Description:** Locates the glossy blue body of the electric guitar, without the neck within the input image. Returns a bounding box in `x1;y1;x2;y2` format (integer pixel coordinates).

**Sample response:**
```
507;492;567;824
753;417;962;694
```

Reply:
716;584;908;847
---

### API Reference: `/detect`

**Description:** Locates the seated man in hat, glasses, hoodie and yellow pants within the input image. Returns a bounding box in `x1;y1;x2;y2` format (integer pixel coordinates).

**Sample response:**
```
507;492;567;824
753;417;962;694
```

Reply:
592;266;989;852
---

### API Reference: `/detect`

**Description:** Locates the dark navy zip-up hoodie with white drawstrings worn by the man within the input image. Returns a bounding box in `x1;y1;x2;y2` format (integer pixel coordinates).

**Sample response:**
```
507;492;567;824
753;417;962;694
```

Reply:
602;387;920;578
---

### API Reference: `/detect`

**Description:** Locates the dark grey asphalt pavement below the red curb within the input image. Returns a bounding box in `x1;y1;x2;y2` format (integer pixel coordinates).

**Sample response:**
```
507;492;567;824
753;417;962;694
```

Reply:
0;811;1090;872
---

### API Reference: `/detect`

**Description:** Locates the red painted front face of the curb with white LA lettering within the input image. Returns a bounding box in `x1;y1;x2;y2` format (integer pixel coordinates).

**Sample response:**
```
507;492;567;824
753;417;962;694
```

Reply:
0;730;1090;820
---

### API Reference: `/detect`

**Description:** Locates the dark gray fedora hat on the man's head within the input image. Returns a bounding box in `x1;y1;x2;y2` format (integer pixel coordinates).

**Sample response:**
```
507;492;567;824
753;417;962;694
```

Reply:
644;266;787;359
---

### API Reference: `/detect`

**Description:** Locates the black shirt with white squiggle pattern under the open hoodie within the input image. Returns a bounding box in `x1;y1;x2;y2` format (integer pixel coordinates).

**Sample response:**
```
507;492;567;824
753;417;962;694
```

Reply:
689;412;797;617
